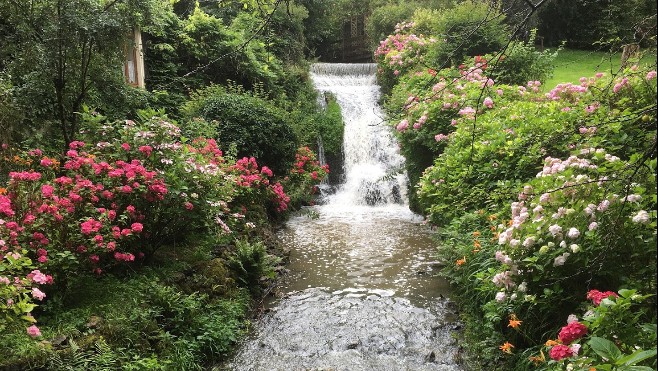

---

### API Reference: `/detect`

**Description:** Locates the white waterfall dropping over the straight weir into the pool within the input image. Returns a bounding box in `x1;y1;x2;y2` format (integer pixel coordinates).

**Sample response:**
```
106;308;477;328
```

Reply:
311;63;407;206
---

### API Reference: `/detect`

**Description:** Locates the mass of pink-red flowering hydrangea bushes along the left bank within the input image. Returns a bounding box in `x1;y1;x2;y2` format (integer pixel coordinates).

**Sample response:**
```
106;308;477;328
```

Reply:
0;108;323;337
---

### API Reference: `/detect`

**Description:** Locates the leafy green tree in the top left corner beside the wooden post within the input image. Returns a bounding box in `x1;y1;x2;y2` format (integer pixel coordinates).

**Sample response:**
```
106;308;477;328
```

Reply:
0;0;166;145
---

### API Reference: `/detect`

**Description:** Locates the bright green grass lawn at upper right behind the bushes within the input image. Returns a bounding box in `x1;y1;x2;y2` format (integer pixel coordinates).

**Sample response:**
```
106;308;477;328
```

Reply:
544;49;656;89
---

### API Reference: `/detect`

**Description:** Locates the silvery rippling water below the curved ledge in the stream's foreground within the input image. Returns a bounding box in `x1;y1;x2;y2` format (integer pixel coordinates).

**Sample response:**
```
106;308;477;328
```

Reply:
228;288;461;371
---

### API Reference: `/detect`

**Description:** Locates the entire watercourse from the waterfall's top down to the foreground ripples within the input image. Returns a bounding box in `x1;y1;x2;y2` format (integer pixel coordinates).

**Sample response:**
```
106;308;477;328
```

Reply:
223;63;461;371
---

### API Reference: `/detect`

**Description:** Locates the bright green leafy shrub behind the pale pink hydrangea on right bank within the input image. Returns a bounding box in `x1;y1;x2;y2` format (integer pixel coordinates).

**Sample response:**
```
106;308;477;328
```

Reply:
419;65;655;224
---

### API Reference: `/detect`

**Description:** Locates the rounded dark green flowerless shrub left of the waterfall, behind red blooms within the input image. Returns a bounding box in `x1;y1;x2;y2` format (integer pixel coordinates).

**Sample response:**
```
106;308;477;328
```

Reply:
187;87;297;174
